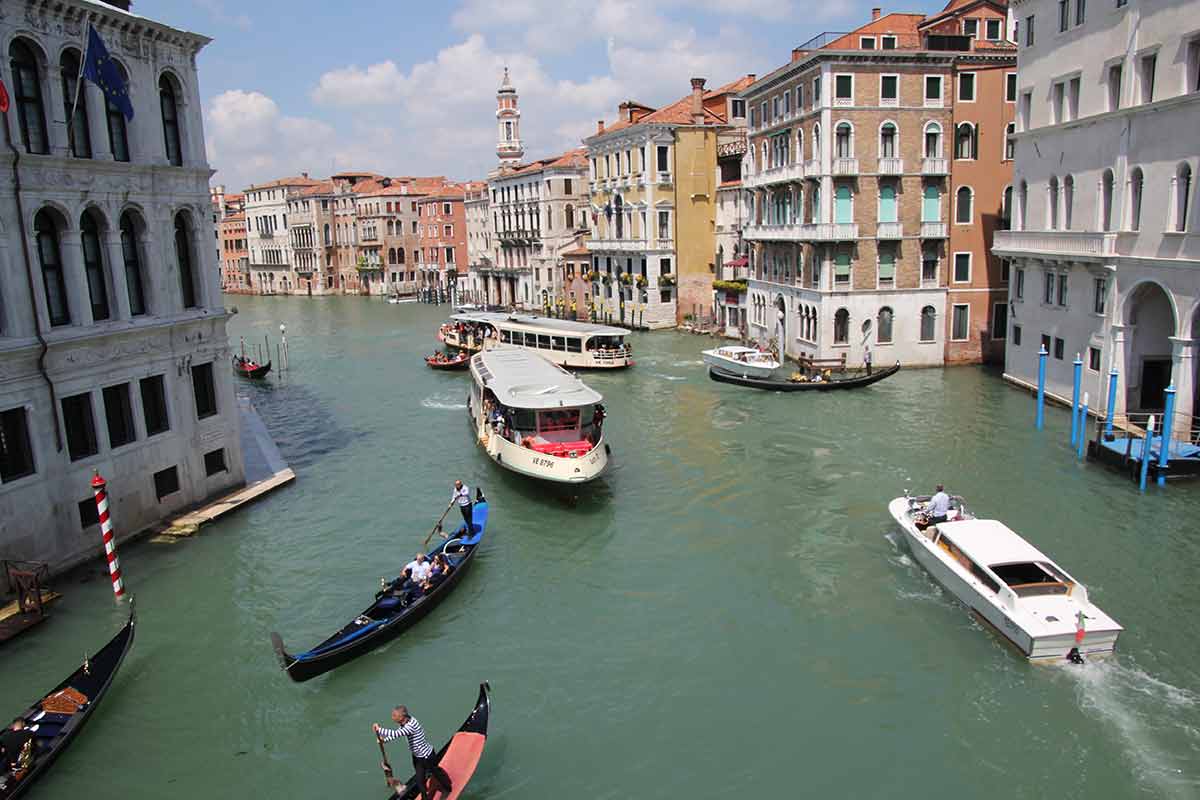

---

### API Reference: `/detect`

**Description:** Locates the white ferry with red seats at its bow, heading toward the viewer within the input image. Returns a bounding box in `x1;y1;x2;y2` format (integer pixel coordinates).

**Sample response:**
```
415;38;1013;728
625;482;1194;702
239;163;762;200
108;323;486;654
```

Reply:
467;344;608;483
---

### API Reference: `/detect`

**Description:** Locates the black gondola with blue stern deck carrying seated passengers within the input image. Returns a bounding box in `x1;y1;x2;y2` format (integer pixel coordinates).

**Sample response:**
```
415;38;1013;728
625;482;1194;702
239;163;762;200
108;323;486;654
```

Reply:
271;489;487;682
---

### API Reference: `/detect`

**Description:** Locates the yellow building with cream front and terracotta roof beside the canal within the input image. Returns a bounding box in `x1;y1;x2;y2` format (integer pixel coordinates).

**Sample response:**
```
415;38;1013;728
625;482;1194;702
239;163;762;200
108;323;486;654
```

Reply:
584;76;755;327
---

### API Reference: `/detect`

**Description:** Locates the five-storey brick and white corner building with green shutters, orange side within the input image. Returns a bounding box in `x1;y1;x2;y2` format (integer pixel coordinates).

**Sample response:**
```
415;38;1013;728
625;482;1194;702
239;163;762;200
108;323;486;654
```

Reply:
743;0;1015;366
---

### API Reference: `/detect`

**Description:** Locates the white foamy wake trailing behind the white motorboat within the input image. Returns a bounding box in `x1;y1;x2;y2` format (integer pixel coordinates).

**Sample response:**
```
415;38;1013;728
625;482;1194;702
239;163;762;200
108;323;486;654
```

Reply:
1058;656;1200;798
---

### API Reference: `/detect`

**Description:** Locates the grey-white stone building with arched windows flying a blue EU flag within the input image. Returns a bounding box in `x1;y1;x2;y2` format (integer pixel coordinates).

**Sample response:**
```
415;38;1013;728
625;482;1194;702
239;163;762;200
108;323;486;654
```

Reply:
0;0;244;569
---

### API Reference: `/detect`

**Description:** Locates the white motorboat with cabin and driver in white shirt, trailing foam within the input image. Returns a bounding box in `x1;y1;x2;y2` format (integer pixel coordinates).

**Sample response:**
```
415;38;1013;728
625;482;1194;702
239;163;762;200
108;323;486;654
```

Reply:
888;495;1123;662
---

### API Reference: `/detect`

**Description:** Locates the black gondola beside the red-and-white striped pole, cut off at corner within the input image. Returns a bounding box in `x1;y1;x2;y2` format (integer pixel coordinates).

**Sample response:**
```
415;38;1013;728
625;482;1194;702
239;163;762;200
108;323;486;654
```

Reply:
0;600;134;800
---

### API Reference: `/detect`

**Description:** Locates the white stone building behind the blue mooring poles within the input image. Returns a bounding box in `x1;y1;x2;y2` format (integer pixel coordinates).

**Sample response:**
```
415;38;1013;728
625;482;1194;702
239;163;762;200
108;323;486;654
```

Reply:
994;0;1200;432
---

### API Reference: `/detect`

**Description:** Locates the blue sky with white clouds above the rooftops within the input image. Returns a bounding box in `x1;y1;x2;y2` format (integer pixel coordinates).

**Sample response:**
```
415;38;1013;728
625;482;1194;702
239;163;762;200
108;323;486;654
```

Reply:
147;0;944;191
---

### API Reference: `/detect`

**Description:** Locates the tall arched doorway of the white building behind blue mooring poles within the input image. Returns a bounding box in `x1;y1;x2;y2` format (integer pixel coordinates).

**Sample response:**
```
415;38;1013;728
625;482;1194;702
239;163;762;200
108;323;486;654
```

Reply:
1124;282;1176;413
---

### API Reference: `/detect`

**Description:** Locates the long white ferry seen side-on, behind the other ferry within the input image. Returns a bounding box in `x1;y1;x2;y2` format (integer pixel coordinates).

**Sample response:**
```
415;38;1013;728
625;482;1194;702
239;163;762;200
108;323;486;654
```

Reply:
438;311;634;369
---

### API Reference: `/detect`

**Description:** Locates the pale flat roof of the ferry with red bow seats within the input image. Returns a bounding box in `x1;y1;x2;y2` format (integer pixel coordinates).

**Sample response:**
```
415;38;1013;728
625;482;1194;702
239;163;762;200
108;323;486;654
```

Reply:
470;345;604;410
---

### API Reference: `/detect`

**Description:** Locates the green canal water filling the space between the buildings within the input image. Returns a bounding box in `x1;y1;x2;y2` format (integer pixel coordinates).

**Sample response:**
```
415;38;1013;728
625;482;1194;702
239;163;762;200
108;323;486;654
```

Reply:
0;297;1200;800
